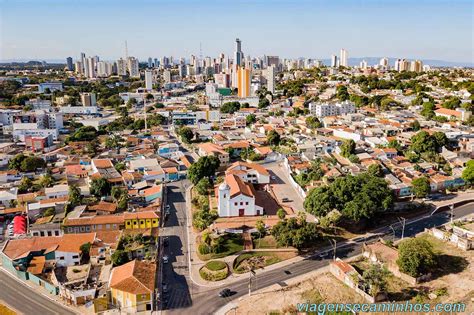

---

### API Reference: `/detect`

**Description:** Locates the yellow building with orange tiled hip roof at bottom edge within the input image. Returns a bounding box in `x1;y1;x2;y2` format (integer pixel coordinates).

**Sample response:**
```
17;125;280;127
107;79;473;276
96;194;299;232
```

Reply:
109;260;156;313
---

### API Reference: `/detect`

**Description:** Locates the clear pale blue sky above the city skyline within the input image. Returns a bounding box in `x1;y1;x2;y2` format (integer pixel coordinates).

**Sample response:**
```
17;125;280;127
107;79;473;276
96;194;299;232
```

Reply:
0;0;474;62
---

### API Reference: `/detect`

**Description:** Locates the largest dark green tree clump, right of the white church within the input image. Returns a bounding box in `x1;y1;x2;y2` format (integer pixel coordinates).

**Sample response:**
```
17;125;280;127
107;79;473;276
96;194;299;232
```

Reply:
304;173;393;222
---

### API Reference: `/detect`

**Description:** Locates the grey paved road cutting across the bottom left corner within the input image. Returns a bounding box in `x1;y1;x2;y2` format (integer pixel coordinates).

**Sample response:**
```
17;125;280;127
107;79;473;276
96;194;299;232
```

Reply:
0;271;74;315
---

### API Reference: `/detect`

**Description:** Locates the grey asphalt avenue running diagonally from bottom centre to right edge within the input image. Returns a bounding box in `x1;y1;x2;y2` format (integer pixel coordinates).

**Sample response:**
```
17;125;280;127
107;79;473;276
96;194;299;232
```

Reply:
168;204;474;314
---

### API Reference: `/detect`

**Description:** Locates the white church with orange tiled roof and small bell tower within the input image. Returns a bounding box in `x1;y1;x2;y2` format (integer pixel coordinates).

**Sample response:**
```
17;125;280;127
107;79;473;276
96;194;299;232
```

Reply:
217;174;263;217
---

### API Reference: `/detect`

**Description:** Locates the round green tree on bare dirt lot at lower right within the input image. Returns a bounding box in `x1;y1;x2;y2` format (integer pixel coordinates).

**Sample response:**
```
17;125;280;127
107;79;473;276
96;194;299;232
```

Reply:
397;238;436;277
